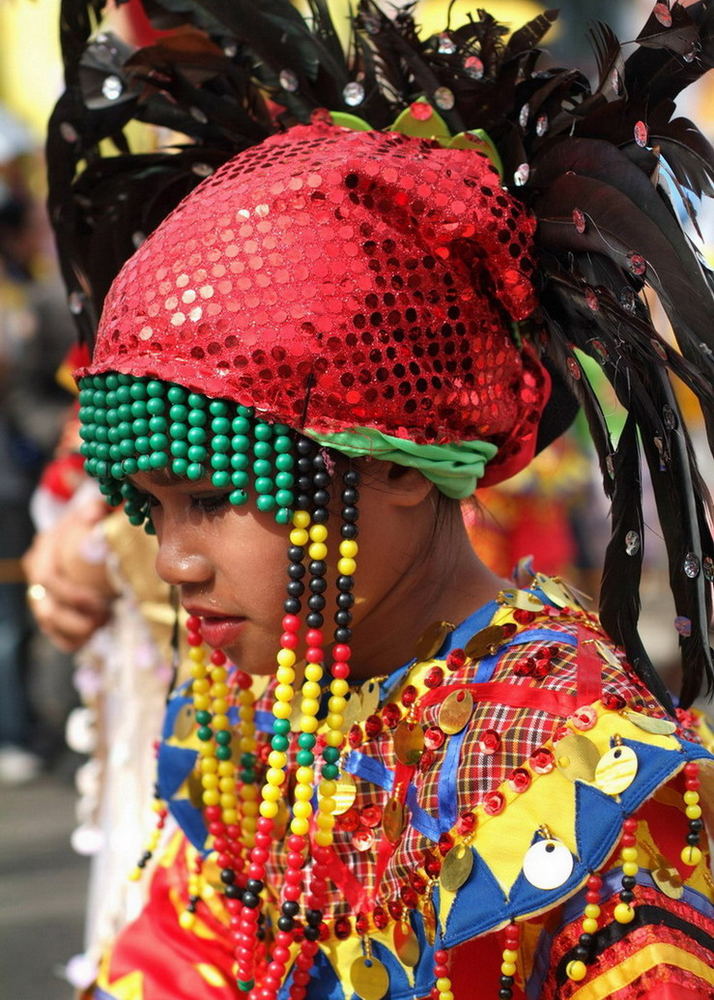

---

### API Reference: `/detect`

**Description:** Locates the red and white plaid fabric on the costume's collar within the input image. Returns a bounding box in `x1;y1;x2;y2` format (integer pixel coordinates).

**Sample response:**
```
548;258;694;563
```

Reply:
257;608;662;917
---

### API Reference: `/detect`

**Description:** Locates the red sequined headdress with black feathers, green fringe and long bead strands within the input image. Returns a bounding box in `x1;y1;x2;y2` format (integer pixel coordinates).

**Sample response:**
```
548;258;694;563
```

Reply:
49;0;714;996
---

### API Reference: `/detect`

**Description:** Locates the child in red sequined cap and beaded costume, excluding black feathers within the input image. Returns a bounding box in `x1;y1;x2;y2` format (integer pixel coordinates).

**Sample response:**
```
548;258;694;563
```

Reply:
54;1;714;1000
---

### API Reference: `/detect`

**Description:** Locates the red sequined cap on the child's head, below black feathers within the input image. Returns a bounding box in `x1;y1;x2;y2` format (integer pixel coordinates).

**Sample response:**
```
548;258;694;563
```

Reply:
88;124;548;481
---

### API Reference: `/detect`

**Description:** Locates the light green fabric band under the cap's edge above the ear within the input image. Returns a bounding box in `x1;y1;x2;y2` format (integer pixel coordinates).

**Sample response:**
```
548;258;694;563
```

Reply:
303;427;498;500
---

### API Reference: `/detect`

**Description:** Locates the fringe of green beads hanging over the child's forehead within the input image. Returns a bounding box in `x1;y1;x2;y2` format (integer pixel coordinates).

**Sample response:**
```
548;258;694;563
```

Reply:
79;372;295;533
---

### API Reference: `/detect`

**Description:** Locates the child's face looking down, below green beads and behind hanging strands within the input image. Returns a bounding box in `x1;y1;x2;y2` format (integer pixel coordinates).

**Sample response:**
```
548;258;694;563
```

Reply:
132;463;423;674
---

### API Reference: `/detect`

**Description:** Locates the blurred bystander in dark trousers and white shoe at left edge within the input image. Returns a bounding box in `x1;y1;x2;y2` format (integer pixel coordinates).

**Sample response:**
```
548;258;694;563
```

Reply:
0;120;73;783
